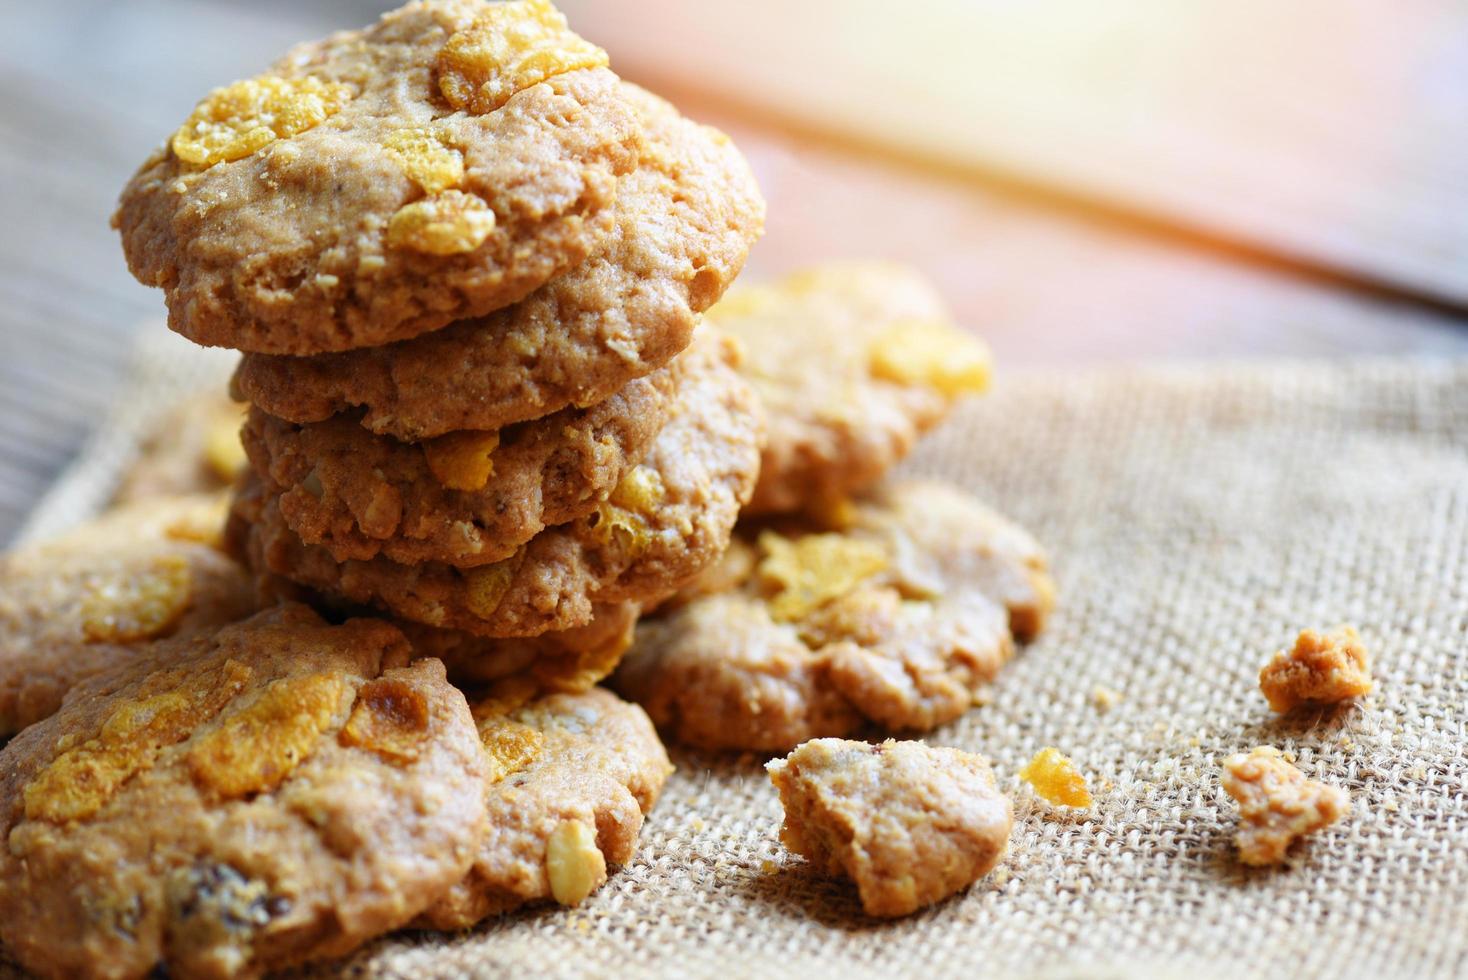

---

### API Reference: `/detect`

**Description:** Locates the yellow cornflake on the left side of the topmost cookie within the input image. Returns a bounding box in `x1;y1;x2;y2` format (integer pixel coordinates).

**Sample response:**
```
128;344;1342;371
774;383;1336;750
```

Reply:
172;75;352;167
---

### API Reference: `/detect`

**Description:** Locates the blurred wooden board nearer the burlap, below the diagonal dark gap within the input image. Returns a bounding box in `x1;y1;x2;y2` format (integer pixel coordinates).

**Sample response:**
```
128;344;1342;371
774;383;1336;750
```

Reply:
0;0;1468;540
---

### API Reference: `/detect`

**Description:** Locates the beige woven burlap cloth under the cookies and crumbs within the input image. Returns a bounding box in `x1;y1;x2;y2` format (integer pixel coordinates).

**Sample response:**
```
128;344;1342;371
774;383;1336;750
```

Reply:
5;333;1468;980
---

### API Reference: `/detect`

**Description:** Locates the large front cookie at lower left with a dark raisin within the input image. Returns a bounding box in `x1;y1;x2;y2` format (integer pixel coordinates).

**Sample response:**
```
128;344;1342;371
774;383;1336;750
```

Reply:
0;606;487;977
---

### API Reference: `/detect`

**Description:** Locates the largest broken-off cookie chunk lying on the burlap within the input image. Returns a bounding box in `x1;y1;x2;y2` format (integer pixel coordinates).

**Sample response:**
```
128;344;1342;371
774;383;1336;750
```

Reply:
766;738;1013;917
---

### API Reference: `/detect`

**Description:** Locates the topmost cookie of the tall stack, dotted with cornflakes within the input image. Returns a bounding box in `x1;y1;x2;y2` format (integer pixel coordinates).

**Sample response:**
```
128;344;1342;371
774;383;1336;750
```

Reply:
113;0;642;355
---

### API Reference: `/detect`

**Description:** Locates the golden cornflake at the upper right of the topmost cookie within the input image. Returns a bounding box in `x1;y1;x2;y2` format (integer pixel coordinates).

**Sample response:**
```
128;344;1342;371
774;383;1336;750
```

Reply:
437;0;608;114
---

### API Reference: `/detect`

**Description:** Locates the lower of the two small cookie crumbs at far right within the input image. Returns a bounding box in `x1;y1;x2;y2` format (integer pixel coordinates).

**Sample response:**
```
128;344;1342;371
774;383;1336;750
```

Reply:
1223;745;1351;864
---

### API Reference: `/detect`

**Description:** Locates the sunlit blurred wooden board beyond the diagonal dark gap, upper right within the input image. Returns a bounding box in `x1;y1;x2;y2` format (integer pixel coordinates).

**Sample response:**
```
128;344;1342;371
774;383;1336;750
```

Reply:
562;0;1468;308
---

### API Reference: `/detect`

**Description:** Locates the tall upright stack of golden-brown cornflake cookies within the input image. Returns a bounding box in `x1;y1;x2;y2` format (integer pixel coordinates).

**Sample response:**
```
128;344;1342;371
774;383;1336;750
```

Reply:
117;0;762;684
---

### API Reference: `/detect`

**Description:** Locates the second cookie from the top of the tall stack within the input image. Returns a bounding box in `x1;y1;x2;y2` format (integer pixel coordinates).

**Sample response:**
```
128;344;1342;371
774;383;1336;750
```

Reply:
235;84;765;440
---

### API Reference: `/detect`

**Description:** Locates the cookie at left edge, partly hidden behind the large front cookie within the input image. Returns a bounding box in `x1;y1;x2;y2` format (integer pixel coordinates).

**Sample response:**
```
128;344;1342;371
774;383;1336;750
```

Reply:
0;496;255;735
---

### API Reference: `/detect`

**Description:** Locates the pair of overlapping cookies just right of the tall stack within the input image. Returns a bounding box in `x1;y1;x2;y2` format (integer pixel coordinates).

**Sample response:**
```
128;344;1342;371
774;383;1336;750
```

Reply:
612;264;1054;753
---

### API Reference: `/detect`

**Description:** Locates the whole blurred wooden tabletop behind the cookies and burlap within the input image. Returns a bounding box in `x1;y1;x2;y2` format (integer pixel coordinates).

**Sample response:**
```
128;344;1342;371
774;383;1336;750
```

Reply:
0;0;1468;540
